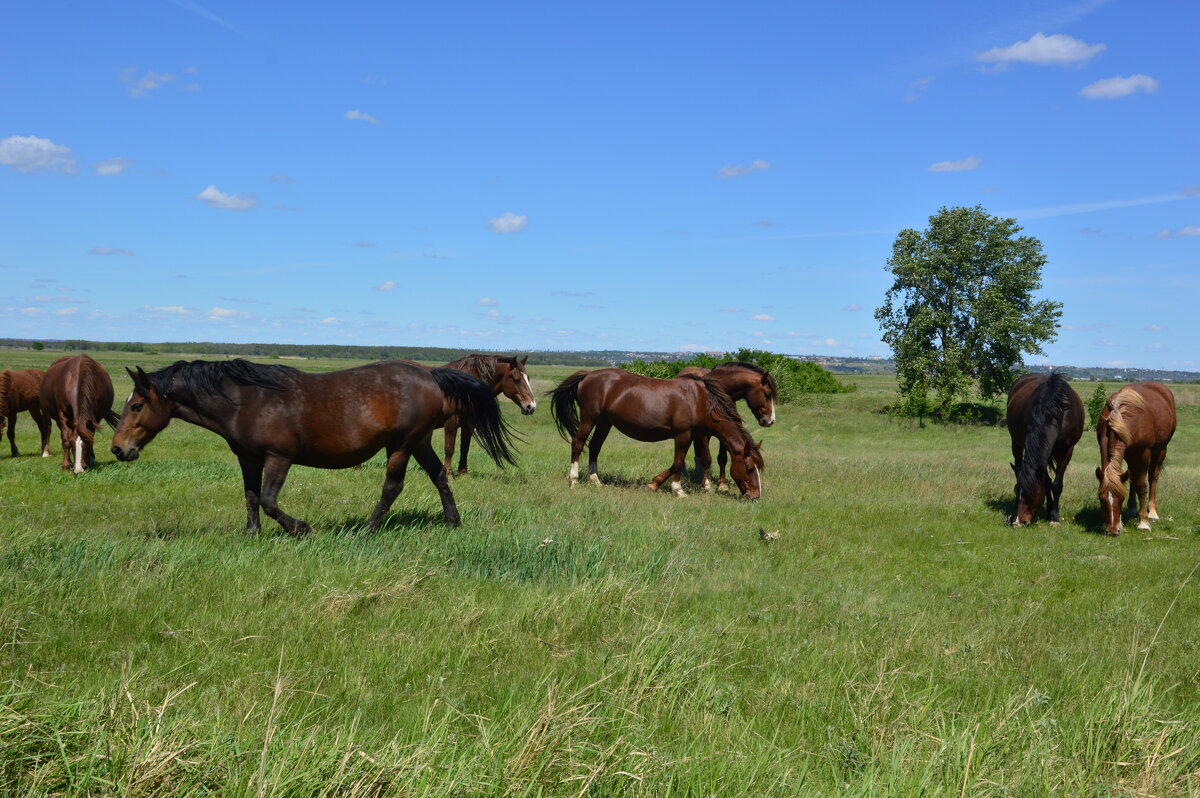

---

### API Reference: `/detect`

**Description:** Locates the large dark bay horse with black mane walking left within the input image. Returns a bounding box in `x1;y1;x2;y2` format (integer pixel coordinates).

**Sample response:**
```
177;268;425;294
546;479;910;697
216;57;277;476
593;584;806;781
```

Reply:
113;360;514;535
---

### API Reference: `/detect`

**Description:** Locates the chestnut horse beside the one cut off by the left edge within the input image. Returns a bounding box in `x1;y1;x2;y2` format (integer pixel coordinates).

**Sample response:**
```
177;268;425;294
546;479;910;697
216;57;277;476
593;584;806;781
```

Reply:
38;355;116;474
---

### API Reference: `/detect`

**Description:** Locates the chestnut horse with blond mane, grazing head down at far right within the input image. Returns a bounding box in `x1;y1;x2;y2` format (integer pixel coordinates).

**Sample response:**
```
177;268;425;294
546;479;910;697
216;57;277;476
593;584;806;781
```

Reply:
1096;383;1175;535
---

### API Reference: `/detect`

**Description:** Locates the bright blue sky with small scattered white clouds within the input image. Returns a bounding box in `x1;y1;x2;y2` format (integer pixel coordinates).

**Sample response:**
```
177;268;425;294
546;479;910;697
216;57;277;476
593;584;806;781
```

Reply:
0;0;1200;368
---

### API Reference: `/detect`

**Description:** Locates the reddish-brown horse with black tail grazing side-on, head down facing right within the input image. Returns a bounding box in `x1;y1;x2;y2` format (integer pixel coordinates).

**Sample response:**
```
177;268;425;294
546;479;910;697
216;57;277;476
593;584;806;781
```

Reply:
550;368;763;499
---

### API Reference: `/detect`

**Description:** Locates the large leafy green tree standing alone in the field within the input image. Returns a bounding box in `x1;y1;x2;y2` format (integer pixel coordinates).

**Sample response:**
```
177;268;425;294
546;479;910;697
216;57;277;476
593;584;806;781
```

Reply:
875;205;1062;415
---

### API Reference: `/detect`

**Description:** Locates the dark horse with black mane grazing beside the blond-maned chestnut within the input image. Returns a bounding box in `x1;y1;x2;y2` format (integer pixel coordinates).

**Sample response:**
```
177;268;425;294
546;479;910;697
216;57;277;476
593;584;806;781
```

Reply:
1008;373;1084;527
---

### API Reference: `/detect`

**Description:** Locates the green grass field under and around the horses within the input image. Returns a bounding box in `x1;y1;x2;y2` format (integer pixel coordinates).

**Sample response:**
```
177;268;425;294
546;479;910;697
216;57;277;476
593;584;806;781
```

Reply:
0;352;1200;797
